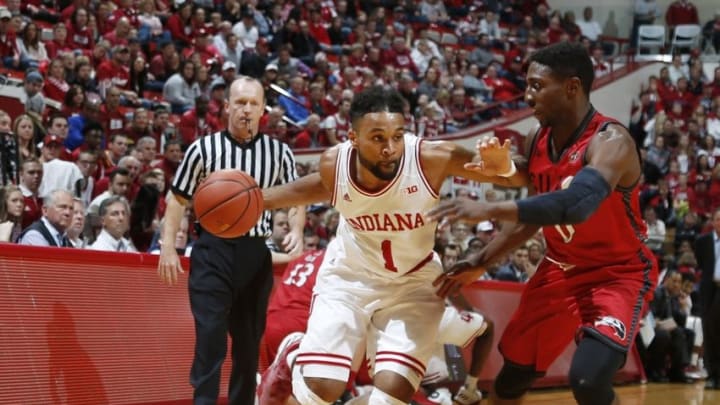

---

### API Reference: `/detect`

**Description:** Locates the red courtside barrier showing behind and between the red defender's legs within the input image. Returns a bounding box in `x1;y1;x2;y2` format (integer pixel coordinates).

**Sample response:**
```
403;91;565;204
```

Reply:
463;281;645;389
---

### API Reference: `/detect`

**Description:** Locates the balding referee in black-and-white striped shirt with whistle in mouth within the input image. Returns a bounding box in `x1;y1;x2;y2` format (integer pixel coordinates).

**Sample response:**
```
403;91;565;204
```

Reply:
158;76;305;405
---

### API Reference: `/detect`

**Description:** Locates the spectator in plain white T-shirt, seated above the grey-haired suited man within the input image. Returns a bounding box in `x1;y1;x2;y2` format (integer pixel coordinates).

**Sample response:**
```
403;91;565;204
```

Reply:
39;135;83;198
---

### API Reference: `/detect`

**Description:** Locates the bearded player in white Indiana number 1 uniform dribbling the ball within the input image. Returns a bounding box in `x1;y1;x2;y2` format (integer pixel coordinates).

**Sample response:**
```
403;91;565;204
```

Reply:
261;87;526;405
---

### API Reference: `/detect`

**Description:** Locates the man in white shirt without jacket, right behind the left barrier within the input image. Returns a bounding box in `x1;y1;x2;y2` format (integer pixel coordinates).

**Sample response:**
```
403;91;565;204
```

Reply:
90;195;137;253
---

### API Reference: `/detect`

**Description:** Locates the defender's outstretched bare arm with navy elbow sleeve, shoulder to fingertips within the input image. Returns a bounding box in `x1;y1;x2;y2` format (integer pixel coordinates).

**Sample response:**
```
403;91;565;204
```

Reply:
428;125;641;225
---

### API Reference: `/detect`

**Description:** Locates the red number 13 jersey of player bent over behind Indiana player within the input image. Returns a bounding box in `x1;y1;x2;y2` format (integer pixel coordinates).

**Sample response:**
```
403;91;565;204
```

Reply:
268;250;325;322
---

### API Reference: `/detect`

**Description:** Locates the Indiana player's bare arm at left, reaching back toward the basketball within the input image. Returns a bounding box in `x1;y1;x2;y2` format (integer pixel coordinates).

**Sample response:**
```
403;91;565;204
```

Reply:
262;148;337;210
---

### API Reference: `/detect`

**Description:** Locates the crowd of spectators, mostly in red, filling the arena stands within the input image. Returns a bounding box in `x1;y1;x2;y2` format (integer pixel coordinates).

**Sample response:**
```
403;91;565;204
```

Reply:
0;0;720;388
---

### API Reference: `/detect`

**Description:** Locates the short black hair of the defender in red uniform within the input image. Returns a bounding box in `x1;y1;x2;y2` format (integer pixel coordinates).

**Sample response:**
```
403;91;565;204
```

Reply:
530;42;595;97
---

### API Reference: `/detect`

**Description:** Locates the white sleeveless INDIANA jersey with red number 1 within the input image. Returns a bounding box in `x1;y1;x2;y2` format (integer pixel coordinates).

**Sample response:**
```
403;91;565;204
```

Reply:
332;134;438;278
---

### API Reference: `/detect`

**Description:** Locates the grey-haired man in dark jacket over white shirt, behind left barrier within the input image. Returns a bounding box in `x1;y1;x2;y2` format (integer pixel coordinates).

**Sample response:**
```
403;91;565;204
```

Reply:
18;190;73;247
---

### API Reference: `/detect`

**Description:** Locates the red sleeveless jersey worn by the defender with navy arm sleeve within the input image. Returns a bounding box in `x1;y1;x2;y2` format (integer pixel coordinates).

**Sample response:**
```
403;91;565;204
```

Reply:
529;110;652;270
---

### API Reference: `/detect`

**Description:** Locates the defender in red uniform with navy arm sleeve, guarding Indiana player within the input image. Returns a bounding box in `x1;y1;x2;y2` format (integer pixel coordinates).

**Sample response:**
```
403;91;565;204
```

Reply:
429;42;657;405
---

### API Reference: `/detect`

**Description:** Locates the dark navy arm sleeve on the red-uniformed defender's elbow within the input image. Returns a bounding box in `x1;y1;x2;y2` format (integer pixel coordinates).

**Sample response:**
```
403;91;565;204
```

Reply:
517;167;611;225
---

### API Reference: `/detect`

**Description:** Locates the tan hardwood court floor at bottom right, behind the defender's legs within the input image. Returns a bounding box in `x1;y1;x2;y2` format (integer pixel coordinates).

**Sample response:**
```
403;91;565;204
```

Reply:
524;381;720;405
